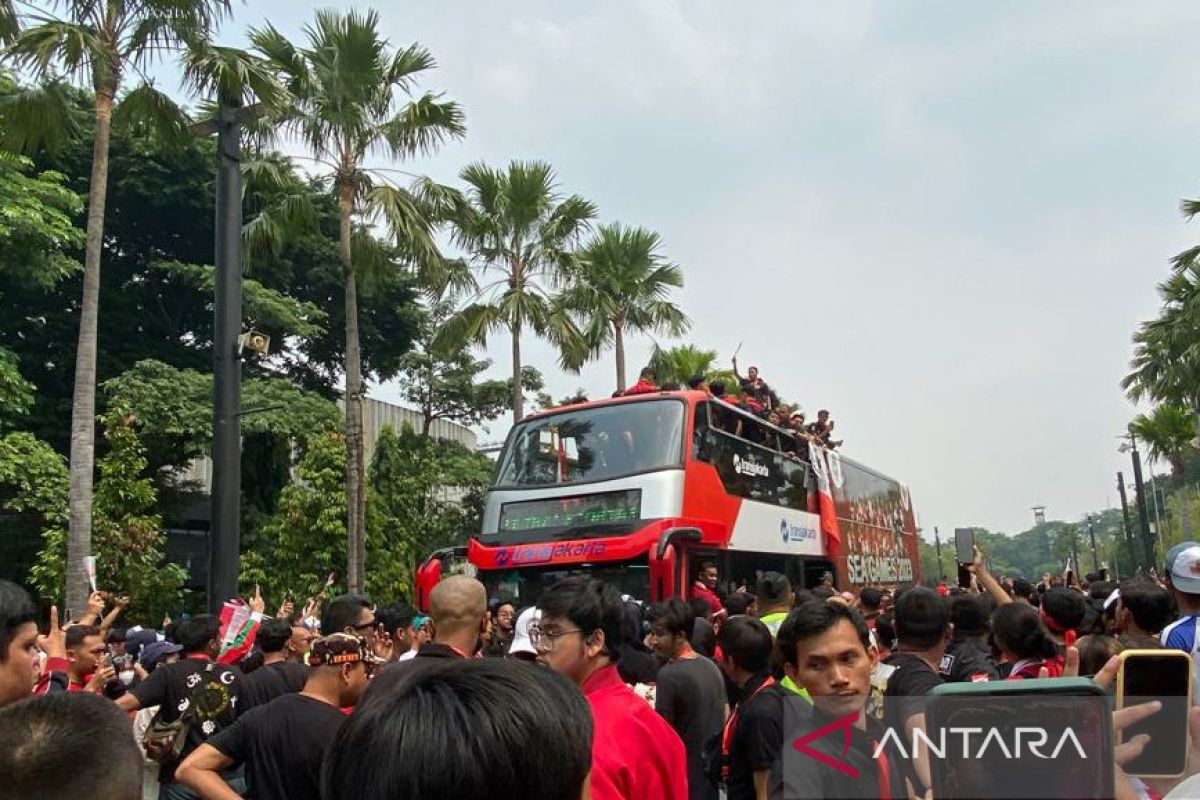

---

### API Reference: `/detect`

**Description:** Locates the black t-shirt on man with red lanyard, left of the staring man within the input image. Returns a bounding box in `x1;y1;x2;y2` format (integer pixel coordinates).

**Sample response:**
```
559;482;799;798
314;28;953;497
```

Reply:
725;673;794;800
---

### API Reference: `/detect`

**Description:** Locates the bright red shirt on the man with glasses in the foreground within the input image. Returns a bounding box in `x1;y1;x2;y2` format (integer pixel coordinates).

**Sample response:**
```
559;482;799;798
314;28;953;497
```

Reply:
581;666;688;800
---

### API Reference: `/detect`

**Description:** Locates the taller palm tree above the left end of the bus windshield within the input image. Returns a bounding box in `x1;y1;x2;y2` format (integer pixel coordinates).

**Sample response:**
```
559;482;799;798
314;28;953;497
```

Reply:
434;161;596;422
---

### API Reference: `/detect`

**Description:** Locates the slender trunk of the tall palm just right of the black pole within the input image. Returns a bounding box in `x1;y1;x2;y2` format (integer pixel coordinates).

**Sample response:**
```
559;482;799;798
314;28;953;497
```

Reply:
338;184;366;593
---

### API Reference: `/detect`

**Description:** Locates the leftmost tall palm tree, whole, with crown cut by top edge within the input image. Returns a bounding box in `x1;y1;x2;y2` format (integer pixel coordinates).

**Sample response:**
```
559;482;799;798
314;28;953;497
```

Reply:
6;0;229;610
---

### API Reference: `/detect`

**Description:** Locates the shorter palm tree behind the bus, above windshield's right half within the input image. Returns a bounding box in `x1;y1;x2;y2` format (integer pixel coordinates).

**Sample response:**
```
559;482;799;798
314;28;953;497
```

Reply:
560;223;691;390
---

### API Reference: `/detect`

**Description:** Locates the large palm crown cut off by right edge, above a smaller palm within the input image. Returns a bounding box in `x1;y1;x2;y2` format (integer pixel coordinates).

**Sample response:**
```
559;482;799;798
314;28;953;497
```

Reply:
1121;263;1200;438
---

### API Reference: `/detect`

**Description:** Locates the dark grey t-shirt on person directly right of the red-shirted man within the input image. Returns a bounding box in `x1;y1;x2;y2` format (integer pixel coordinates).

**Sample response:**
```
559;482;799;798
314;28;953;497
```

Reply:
654;656;725;800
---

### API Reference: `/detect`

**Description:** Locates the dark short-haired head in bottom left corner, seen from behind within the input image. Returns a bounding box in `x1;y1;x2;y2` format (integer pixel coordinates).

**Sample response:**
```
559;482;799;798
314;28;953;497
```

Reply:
0;692;142;800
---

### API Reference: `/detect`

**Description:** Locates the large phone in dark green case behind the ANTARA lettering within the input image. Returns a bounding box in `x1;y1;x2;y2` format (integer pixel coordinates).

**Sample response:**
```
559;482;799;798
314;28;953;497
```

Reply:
926;678;1115;800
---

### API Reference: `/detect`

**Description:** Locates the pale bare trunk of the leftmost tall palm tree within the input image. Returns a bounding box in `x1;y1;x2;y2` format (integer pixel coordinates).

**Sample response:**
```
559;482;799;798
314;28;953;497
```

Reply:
66;90;115;616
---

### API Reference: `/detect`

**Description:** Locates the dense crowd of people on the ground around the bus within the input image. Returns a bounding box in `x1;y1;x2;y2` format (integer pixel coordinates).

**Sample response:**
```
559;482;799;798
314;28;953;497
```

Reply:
7;542;1200;800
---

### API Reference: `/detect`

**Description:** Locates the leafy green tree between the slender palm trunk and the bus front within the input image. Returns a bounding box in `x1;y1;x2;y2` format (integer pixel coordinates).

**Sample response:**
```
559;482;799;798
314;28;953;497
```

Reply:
367;426;494;599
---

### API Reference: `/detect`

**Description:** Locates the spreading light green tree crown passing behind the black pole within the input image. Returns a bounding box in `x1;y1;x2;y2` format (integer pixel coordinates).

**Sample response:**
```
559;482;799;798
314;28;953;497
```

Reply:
103;360;338;479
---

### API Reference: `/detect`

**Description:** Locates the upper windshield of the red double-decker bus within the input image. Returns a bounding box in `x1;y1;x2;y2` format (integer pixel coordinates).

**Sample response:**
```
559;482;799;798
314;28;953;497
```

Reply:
496;399;685;487
